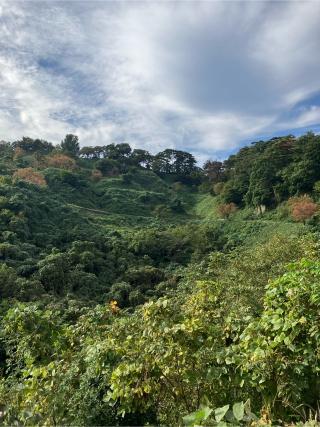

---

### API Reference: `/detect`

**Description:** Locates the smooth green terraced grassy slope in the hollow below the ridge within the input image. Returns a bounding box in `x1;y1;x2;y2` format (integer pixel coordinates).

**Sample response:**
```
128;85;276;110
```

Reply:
52;170;196;229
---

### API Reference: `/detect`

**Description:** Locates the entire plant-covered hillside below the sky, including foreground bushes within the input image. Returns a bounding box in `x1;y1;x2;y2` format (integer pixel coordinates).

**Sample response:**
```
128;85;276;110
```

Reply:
0;133;320;426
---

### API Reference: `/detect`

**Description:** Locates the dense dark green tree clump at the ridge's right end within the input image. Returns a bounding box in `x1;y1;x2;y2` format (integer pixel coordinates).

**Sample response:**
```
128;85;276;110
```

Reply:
204;132;320;207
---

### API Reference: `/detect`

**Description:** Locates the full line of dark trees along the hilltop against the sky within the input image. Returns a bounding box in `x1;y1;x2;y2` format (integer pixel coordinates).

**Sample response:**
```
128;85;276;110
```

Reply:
0;132;320;208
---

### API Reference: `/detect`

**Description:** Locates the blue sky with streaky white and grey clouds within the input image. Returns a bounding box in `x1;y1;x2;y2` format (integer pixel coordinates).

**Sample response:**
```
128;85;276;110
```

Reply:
0;0;320;161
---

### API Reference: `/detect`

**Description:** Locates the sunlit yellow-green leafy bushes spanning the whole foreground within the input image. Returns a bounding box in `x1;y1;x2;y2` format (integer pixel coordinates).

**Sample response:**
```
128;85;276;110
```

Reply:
0;252;320;425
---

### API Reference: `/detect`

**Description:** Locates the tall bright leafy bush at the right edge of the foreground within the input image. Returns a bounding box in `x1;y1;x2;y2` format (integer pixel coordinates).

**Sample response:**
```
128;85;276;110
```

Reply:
240;259;320;420
